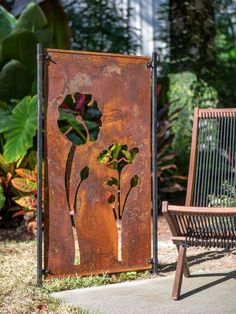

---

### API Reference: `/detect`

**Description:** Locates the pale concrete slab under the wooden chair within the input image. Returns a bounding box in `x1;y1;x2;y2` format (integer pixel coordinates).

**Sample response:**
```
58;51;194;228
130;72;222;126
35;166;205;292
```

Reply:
52;270;236;314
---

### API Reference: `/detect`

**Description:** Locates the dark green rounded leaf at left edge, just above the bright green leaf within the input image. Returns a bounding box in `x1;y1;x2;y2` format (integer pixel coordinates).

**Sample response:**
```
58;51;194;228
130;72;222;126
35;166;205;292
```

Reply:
0;60;32;101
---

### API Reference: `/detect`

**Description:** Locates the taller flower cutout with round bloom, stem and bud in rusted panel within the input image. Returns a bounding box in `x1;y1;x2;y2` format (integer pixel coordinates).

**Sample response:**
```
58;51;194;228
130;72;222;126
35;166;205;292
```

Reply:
57;92;102;264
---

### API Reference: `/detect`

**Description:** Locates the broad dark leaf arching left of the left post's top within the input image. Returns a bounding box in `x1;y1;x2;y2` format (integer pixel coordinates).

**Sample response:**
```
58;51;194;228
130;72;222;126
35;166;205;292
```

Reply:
2;30;37;73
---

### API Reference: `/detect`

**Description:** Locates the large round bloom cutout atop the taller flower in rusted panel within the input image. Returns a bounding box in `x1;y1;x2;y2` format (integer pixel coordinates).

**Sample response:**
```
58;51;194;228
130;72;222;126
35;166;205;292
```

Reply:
58;93;102;145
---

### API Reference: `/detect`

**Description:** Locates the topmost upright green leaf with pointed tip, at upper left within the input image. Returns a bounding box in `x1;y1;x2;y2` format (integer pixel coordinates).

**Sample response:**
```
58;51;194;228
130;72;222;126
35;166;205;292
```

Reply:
15;2;47;33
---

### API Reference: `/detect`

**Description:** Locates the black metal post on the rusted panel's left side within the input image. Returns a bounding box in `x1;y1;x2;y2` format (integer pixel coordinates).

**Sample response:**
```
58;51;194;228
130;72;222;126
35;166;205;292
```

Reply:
37;44;44;287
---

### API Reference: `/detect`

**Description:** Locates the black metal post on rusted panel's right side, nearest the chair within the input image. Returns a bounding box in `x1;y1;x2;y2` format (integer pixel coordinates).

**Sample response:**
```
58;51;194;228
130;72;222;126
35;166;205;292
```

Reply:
151;52;158;274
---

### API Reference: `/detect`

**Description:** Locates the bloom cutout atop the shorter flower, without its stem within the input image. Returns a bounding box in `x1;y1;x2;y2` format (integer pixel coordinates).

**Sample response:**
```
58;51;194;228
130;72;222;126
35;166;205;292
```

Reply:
97;144;139;172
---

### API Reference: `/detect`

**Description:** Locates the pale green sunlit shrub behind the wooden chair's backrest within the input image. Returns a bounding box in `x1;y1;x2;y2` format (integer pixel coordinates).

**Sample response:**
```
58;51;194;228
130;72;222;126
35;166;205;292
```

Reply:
168;72;218;174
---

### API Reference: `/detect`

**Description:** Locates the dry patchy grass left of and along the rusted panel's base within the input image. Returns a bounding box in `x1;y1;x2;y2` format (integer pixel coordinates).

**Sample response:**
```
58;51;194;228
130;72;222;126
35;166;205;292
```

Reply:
0;232;150;314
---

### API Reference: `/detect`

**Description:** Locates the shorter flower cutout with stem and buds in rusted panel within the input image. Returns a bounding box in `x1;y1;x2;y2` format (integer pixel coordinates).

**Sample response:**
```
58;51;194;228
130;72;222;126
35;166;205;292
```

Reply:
97;144;139;261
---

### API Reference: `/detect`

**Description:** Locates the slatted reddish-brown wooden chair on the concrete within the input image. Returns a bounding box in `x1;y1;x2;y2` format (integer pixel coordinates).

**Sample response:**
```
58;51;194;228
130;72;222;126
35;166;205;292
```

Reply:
162;108;236;300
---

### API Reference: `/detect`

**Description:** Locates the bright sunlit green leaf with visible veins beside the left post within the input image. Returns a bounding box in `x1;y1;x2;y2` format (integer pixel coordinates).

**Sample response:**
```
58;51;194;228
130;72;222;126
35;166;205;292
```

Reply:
4;96;37;163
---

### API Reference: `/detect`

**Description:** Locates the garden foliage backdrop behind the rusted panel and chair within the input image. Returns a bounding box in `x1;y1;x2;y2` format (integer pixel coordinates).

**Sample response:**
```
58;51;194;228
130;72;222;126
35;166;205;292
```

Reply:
0;0;236;223
